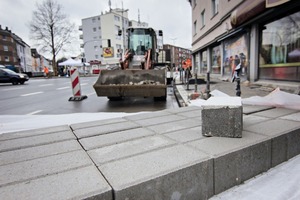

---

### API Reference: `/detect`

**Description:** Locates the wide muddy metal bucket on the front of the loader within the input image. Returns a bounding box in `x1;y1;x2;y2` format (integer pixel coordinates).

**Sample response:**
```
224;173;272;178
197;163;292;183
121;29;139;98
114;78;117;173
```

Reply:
93;70;167;97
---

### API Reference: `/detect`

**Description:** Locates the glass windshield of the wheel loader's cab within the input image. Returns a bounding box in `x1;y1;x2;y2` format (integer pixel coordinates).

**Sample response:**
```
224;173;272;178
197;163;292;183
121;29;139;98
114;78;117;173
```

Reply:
128;29;155;55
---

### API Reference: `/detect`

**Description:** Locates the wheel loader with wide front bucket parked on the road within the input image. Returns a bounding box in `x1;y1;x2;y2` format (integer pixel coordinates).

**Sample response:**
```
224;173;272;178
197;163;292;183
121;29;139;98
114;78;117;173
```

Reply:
93;27;167;101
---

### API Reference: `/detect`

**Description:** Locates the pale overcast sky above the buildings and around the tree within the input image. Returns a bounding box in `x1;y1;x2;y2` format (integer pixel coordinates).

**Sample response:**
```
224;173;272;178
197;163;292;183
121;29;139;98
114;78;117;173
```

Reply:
0;0;192;57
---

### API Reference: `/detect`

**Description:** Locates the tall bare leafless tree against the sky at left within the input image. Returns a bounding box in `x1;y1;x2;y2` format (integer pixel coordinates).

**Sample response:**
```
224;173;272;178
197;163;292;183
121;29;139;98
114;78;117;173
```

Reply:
29;0;75;75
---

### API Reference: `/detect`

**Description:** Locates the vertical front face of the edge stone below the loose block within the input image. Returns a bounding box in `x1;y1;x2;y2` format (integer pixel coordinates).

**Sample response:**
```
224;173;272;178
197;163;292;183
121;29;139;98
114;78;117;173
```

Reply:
214;141;271;194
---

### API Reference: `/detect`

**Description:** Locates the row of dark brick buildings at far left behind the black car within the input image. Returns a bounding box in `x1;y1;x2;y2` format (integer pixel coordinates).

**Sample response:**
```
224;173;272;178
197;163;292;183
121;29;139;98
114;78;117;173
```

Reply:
0;25;32;72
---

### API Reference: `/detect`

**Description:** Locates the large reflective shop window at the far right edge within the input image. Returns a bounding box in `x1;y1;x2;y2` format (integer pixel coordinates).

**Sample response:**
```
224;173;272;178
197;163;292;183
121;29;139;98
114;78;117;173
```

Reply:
259;12;300;81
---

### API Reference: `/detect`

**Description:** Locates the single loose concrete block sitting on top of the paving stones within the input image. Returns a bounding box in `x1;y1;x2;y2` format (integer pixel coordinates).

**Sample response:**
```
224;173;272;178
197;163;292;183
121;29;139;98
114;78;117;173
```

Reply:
201;97;243;138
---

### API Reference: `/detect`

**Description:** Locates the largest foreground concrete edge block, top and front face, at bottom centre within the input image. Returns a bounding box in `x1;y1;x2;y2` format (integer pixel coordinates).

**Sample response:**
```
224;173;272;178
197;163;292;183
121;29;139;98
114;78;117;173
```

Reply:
99;145;213;200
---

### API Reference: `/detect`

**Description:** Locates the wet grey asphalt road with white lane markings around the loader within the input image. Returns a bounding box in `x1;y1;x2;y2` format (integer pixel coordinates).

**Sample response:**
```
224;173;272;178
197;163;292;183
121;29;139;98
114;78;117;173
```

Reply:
0;76;178;115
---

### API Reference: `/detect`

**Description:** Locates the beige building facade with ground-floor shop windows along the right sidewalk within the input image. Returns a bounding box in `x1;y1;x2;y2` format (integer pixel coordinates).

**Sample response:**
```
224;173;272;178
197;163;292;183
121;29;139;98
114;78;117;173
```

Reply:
189;0;300;83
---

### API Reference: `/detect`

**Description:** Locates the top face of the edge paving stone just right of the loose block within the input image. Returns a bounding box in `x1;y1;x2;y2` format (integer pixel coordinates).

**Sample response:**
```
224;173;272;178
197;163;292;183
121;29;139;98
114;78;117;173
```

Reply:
244;119;300;137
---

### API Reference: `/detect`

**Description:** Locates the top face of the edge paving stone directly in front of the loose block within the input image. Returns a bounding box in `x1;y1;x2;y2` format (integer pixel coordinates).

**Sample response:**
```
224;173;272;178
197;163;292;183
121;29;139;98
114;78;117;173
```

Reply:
187;131;269;158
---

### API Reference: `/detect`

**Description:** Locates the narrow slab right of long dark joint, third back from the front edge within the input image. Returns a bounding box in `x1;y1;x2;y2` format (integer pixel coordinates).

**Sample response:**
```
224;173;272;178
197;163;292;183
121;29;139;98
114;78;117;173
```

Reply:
79;128;155;150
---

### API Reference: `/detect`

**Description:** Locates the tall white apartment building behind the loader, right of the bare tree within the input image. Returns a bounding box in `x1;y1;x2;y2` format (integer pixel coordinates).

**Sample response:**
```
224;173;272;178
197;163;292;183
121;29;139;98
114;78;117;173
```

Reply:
79;8;129;64
